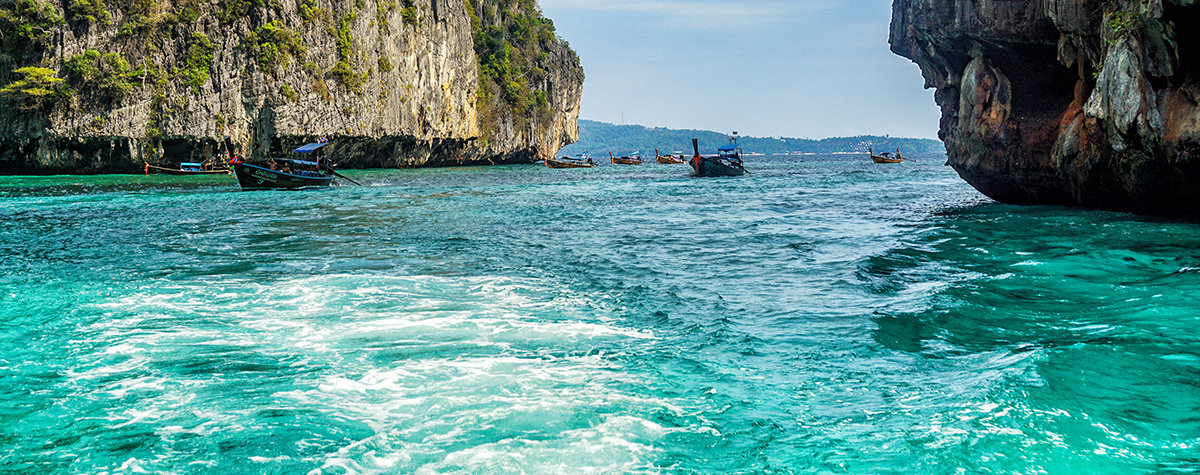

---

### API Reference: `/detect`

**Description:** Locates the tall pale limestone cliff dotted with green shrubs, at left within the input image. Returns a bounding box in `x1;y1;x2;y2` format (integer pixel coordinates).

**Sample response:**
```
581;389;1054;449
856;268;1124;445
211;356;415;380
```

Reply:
0;0;583;174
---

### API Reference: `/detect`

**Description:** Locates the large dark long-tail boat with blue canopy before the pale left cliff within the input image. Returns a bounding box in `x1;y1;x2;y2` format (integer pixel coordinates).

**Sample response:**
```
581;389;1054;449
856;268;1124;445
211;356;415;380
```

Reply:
229;142;336;190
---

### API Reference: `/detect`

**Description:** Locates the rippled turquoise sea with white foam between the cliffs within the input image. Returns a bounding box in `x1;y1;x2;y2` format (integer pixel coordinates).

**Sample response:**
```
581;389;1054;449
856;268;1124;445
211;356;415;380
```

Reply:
0;156;1200;474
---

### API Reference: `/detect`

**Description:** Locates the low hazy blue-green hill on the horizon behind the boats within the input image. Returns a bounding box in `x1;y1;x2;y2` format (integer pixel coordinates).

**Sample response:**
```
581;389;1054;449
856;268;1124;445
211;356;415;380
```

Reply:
558;120;946;156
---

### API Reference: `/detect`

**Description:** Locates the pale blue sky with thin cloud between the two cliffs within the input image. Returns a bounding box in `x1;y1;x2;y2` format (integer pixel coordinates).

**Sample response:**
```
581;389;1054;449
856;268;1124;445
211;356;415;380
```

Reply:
539;0;940;138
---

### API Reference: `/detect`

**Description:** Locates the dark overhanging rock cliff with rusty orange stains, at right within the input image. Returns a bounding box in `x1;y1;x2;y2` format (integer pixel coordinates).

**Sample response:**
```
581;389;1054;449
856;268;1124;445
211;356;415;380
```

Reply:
890;0;1200;217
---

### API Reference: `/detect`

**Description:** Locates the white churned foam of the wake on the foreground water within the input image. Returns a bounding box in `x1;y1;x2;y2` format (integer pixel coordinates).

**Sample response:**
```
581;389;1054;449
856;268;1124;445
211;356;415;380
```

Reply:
72;275;676;473
